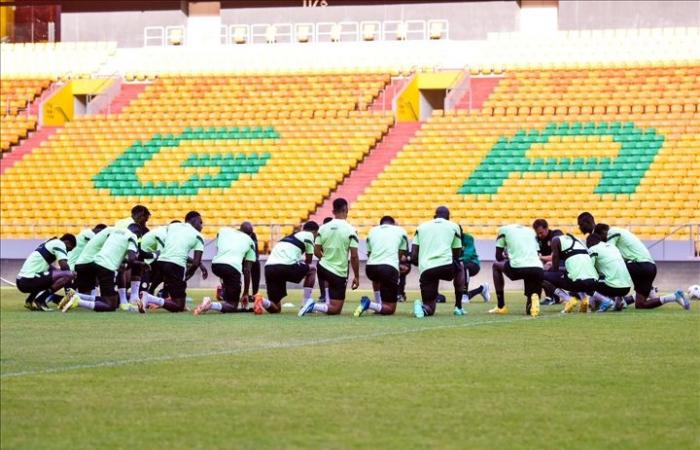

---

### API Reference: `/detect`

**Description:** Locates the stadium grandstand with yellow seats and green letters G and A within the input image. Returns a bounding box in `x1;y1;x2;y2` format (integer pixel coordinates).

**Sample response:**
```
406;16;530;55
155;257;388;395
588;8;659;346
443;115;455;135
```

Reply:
0;1;700;278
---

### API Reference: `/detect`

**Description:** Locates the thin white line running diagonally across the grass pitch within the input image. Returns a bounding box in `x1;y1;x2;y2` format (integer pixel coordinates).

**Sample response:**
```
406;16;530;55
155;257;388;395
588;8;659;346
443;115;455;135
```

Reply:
0;314;561;379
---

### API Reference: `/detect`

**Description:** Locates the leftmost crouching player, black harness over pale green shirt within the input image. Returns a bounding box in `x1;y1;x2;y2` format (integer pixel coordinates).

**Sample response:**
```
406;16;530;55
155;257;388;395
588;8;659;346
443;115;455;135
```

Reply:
17;233;75;311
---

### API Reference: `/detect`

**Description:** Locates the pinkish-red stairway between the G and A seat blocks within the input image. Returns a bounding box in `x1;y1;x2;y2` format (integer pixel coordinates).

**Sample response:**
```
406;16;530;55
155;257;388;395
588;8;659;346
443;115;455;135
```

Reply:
309;122;421;223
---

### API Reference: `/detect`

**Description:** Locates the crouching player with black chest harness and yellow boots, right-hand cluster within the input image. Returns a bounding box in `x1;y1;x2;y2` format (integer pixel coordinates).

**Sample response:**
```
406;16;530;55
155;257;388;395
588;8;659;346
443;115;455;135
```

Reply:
544;234;598;313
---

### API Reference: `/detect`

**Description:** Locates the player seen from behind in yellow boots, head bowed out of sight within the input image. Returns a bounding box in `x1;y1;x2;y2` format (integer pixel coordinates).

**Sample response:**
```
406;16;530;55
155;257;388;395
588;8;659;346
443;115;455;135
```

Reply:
489;224;544;317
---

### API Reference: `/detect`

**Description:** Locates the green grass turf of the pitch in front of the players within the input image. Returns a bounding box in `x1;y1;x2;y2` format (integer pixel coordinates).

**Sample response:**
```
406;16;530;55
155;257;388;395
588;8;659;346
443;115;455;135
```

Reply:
0;289;700;449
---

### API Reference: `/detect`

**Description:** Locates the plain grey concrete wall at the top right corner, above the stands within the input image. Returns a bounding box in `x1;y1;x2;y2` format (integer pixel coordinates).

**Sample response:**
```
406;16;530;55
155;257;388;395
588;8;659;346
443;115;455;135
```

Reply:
559;0;700;30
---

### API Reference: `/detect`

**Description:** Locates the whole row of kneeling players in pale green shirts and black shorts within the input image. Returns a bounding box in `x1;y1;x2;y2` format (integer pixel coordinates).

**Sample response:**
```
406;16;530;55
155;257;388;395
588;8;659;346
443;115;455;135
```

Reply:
17;198;690;318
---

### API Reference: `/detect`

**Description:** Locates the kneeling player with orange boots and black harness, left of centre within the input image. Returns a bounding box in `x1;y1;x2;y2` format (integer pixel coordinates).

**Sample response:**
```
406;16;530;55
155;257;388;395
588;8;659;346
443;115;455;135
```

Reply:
253;220;319;314
